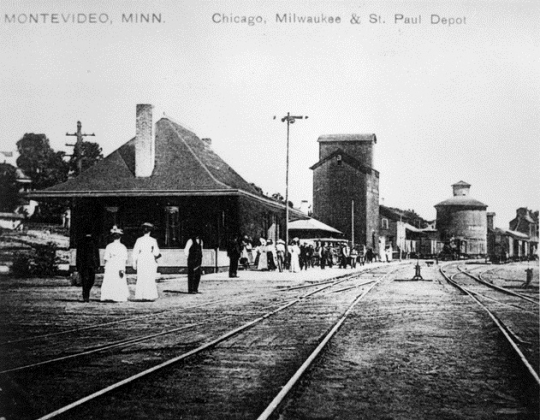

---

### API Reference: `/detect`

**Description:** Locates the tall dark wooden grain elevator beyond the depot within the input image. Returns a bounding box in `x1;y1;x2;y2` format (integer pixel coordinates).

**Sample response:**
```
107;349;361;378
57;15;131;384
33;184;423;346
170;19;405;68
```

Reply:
311;134;379;251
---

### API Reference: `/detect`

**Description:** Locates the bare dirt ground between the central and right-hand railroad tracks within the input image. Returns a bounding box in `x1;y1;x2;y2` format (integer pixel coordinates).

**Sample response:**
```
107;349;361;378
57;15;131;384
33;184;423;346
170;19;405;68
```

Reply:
280;264;539;420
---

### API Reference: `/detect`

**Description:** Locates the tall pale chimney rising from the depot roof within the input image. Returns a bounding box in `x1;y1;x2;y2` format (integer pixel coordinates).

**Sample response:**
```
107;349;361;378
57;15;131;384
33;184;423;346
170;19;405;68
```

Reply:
135;104;155;178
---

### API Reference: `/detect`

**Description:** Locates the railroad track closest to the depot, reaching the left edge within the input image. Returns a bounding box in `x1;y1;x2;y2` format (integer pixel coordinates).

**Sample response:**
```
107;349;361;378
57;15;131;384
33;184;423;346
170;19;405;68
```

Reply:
0;269;380;374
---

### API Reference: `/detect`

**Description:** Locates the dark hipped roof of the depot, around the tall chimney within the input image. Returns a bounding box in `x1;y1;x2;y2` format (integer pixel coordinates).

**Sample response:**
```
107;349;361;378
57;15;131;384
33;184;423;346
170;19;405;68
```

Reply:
29;118;262;198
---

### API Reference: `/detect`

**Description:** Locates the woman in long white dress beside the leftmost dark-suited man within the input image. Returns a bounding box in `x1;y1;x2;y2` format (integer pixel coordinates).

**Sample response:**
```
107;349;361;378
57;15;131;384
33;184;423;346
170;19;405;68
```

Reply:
101;226;129;302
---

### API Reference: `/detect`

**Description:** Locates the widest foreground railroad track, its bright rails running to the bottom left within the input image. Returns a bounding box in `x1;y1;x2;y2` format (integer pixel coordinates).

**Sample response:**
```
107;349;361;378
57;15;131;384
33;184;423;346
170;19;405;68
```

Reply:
0;266;395;419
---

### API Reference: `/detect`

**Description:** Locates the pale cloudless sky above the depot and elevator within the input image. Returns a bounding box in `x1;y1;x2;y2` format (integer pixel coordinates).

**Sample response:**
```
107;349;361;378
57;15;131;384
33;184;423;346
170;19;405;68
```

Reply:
0;0;540;227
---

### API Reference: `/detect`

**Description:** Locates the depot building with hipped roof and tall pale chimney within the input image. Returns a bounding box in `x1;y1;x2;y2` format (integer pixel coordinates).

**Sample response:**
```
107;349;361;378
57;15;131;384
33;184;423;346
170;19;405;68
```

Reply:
28;104;307;273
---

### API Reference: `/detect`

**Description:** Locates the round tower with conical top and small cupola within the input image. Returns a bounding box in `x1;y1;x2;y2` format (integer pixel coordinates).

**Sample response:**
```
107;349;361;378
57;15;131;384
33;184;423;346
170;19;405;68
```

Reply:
435;181;488;255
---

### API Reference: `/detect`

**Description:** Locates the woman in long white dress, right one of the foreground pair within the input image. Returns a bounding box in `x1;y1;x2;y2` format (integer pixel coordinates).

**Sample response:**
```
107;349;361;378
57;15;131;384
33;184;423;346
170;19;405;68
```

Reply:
133;223;161;300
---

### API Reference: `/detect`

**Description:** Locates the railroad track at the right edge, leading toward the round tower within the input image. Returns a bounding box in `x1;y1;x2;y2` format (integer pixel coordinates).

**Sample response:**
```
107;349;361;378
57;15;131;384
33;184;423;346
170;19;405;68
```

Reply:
440;263;540;386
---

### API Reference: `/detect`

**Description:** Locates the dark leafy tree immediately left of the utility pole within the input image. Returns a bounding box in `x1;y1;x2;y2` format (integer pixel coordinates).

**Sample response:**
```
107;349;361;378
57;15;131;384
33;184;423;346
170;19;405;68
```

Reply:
17;133;69;190
